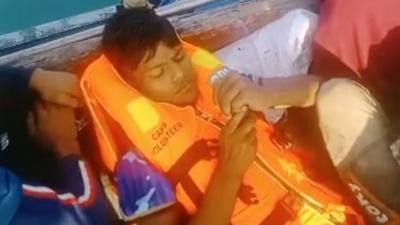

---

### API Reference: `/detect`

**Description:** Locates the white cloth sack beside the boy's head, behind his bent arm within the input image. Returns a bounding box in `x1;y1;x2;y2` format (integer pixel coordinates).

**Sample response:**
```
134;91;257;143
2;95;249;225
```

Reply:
216;9;318;122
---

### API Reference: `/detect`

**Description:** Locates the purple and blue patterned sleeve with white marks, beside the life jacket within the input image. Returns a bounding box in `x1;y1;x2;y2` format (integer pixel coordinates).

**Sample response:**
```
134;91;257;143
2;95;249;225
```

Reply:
116;151;176;219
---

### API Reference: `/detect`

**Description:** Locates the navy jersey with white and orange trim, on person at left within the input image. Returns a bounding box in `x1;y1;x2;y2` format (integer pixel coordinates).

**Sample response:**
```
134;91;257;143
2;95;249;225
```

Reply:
15;155;109;225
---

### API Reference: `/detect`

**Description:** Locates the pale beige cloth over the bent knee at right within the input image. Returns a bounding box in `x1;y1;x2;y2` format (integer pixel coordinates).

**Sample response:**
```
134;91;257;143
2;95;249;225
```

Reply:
316;78;390;166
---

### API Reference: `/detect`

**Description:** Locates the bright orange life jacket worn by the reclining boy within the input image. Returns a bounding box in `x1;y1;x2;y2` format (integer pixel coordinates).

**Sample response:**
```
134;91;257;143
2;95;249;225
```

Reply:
81;43;364;225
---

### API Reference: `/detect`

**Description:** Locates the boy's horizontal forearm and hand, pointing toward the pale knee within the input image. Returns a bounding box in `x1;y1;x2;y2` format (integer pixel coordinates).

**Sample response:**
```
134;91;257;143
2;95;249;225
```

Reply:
214;71;321;115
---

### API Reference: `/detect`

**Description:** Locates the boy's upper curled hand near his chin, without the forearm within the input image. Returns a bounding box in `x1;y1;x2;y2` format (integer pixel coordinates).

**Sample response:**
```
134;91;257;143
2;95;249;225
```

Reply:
214;71;269;116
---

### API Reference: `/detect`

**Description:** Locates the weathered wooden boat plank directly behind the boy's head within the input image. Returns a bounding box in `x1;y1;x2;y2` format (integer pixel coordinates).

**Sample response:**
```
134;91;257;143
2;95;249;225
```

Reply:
0;0;317;70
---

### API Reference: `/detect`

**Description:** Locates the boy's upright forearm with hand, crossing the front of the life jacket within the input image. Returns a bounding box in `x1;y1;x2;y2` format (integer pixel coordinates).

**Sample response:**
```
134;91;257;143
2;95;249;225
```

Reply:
134;113;257;225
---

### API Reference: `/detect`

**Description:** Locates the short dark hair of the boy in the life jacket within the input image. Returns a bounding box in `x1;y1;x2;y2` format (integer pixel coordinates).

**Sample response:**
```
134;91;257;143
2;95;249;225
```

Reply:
101;7;180;75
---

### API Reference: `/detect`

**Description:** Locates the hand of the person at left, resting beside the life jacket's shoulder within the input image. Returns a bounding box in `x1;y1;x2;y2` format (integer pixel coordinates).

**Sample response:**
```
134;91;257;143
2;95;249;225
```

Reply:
30;68;81;108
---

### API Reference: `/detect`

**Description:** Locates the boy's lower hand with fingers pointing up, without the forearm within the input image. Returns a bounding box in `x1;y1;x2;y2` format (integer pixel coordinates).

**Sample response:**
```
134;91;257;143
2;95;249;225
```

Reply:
219;113;257;178
